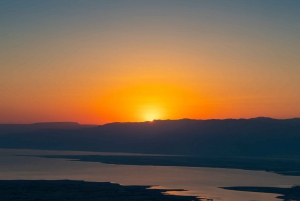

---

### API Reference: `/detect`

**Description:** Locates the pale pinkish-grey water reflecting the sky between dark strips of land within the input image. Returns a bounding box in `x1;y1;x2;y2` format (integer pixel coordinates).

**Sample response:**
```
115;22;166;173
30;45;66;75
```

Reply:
0;149;300;201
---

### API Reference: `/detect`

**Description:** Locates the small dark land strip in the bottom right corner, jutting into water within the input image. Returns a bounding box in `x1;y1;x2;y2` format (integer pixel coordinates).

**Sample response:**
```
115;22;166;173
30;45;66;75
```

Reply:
222;186;300;201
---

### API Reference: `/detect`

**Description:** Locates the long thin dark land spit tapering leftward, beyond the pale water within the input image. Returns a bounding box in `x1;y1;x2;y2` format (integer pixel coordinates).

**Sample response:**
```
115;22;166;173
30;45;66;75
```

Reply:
34;154;300;176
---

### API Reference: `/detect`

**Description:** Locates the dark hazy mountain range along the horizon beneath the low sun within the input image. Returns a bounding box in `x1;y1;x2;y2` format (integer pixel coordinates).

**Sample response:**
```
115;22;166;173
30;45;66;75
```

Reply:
0;117;300;159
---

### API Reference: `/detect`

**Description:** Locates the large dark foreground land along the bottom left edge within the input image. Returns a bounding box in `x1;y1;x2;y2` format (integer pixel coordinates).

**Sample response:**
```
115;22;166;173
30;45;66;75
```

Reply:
0;180;199;201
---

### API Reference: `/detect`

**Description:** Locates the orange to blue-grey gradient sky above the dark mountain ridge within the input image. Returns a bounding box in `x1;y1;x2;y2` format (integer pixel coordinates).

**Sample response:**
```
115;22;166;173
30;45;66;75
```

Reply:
0;0;300;124
